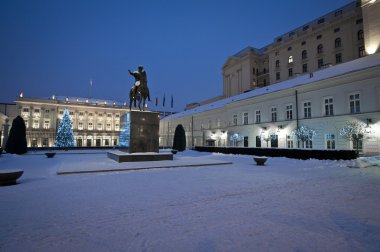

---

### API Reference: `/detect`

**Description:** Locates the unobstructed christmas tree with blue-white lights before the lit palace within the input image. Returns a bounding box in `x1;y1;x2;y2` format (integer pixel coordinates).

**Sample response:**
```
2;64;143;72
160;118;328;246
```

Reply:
54;109;74;147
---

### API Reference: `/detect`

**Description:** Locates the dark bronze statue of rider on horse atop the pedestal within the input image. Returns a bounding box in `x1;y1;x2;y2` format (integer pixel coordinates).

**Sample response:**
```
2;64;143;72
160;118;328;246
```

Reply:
128;66;150;111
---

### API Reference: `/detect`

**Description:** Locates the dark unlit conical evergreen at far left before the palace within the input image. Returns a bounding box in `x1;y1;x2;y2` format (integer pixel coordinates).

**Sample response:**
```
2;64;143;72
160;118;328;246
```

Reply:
5;116;27;154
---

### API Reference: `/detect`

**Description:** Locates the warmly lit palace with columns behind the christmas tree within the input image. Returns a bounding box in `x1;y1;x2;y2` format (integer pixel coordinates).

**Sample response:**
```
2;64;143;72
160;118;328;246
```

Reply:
0;94;129;147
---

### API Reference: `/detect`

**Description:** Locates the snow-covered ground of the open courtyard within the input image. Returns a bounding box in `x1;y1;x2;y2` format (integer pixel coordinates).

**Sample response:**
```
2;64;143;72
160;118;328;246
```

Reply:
0;151;380;251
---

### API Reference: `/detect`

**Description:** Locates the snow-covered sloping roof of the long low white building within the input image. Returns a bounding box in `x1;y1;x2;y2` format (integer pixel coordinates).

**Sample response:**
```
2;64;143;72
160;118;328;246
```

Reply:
162;53;380;121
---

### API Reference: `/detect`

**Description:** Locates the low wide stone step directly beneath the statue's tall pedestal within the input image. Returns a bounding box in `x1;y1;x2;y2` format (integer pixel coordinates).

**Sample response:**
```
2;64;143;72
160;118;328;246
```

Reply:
107;151;173;163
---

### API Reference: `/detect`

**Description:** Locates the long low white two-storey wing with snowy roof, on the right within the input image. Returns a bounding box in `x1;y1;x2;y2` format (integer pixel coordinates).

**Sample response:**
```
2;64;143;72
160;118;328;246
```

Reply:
160;53;380;154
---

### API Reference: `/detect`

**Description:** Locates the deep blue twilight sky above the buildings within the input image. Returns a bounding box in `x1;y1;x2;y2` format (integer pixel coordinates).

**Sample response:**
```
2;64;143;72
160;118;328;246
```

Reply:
0;0;351;111
